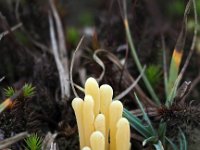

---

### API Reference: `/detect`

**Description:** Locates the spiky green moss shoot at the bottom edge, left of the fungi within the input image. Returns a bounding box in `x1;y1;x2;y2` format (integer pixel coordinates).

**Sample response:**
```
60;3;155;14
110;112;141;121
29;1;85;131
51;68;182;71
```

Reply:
25;133;42;150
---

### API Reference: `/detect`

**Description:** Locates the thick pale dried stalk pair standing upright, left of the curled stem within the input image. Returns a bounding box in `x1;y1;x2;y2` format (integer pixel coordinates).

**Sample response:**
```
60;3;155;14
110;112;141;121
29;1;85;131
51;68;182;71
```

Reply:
49;0;70;99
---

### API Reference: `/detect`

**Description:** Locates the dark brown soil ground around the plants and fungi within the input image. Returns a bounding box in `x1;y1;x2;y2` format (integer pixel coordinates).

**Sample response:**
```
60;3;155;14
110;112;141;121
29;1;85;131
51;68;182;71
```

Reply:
0;0;200;150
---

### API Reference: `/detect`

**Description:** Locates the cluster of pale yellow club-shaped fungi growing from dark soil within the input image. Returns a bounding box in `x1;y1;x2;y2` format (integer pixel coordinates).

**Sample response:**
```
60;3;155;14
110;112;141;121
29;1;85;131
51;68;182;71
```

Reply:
72;78;131;150
